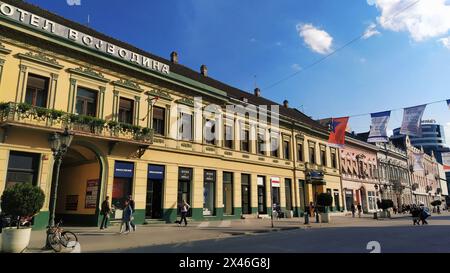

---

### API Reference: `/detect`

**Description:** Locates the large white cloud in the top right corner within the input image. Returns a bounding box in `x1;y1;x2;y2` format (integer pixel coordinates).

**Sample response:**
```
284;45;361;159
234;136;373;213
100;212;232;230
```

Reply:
367;0;450;42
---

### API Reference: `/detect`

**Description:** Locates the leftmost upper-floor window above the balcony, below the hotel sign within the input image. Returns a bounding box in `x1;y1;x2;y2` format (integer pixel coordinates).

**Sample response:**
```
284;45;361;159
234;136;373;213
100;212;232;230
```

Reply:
25;74;49;107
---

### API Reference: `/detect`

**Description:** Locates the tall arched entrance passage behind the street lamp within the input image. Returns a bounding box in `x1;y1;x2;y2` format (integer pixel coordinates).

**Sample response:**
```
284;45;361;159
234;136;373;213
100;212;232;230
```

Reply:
56;141;106;226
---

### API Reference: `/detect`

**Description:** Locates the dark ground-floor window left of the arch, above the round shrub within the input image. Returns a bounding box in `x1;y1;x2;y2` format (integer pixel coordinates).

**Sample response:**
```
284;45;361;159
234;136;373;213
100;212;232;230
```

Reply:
6;151;40;188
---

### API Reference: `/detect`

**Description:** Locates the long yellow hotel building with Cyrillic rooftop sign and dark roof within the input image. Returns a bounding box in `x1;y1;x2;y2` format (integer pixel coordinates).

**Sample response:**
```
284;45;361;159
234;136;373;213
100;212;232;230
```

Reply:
0;1;343;228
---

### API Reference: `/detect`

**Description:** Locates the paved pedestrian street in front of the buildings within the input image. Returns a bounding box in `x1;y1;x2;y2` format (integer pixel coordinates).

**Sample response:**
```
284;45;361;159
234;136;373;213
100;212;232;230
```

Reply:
0;212;450;253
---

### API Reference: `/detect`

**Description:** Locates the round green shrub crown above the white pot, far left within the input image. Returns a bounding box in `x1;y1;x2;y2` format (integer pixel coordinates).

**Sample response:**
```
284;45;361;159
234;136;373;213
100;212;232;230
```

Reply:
1;183;45;228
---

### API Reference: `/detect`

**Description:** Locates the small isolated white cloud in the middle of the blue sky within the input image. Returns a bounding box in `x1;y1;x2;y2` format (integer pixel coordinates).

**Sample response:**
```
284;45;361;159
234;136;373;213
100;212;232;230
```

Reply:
297;24;333;54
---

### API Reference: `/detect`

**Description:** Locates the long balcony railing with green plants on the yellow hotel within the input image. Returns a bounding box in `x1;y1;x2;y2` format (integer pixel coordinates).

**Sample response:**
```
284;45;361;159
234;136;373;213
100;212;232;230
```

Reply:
0;102;153;144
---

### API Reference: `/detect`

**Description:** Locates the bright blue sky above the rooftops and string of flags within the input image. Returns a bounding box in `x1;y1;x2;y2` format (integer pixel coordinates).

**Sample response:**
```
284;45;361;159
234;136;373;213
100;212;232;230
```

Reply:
28;0;450;143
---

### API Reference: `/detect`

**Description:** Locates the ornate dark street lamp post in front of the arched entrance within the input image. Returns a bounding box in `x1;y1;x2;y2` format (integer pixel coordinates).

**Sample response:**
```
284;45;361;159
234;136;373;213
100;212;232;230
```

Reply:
46;127;73;247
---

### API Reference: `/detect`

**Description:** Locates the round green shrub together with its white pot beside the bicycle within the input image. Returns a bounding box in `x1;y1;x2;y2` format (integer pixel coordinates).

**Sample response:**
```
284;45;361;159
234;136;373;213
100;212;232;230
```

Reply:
1;183;45;253
